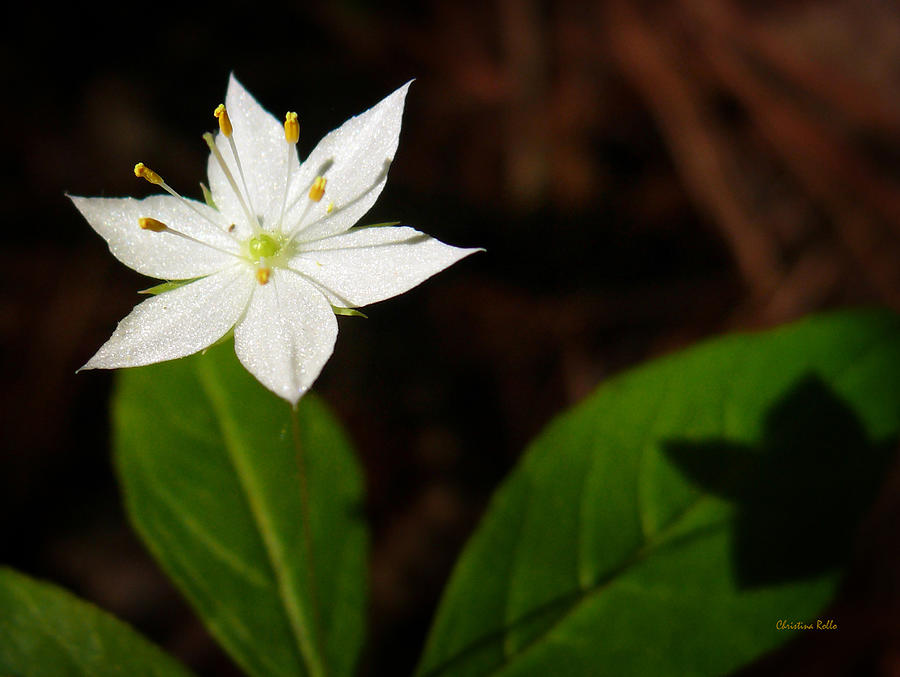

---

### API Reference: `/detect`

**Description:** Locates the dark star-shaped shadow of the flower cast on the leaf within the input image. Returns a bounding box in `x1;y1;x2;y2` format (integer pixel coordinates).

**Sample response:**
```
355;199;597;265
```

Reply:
663;375;896;588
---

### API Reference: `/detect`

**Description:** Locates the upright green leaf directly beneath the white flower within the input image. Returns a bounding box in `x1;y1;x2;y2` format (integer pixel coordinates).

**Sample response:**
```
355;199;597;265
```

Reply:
113;342;367;675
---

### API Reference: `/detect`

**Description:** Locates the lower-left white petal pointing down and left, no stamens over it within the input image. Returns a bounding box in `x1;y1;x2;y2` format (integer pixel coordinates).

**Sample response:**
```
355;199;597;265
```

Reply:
82;265;256;369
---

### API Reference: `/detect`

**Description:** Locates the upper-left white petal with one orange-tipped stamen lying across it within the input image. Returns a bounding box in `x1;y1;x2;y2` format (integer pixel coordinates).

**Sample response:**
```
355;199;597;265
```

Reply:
70;195;240;280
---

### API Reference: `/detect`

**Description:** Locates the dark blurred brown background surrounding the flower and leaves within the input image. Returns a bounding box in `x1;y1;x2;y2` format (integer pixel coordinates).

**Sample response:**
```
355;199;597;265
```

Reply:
0;0;900;675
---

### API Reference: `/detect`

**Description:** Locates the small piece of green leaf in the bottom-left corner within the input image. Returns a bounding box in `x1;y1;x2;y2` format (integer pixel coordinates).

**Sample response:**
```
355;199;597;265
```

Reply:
0;567;191;677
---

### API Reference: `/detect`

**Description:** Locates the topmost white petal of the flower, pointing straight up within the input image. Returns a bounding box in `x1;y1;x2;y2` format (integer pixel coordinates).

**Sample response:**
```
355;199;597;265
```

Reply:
207;75;300;232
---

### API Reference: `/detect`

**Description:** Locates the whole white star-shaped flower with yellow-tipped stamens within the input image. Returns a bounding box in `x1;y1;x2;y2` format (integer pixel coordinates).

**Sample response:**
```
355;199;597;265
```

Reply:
72;76;479;404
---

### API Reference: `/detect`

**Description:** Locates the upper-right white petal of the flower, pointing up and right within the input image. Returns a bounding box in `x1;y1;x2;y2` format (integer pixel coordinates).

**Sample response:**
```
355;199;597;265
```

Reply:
285;82;411;240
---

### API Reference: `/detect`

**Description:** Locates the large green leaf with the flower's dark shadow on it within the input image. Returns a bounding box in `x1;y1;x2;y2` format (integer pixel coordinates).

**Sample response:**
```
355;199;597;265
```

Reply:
418;312;900;676
